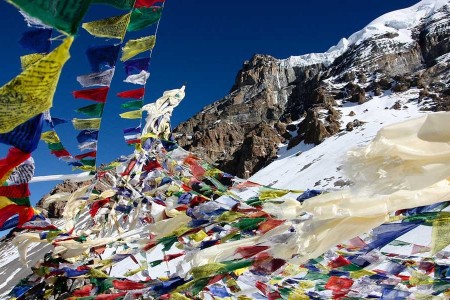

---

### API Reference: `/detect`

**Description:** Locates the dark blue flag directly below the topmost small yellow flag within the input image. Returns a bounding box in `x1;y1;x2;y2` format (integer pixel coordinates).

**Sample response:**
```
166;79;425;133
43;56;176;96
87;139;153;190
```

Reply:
86;45;120;72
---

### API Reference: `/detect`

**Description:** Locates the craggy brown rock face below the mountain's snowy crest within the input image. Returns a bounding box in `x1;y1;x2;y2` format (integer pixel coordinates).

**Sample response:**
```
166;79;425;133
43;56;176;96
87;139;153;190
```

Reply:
174;5;450;177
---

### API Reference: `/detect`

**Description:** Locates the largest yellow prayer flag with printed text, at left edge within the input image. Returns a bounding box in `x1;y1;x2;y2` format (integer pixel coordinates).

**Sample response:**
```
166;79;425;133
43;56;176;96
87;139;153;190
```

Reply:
0;37;73;133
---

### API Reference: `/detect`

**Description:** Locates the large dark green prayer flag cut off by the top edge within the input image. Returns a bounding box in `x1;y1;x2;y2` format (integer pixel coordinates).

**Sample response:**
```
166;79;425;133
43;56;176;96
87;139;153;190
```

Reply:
8;0;91;35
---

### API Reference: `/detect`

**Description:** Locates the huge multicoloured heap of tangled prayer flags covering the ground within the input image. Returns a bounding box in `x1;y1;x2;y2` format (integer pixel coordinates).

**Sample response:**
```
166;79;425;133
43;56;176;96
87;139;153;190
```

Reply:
6;111;450;299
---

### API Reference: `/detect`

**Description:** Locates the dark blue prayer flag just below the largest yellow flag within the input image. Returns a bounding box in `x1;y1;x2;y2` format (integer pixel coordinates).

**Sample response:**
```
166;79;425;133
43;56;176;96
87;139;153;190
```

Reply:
0;114;44;153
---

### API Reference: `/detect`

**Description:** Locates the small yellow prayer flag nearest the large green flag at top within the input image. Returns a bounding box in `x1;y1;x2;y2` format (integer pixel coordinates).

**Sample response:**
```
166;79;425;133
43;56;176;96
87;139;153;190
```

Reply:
81;13;131;40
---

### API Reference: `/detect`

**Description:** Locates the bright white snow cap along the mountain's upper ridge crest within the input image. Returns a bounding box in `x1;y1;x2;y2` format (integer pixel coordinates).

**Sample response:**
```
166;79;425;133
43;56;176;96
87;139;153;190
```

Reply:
281;0;450;67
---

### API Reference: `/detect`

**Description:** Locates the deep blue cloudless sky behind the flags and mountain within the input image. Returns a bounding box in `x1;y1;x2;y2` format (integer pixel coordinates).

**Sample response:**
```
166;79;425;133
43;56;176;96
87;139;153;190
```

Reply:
0;0;418;202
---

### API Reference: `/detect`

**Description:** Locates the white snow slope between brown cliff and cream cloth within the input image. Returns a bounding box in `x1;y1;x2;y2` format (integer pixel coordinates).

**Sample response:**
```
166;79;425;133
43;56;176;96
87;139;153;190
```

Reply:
250;89;423;190
